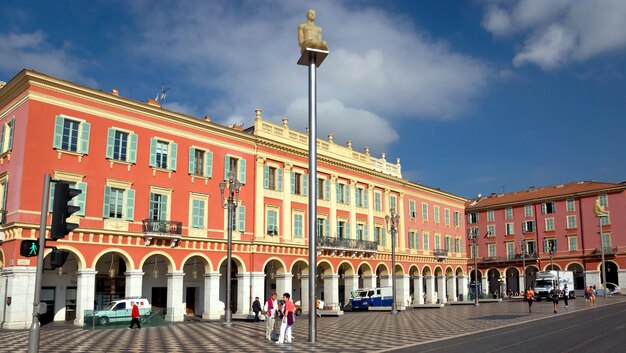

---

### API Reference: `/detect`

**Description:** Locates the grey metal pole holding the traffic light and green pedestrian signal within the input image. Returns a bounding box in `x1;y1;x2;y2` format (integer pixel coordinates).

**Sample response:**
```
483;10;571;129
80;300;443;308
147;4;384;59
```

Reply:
28;173;50;353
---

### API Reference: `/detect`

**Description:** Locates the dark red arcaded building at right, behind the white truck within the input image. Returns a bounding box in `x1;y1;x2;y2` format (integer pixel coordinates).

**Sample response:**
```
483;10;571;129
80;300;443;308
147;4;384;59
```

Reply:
466;181;626;295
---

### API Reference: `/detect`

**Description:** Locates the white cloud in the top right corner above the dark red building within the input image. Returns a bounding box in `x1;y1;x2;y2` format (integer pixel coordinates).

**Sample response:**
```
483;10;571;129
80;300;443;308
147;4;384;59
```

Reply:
483;0;626;70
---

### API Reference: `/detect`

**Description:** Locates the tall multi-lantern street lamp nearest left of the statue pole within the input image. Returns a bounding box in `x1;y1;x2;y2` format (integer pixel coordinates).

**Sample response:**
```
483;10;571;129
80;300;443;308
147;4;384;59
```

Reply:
220;169;241;326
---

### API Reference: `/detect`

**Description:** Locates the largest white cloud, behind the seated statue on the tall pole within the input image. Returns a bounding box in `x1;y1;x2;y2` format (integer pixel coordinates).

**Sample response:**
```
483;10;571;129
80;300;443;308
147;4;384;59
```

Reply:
128;0;493;148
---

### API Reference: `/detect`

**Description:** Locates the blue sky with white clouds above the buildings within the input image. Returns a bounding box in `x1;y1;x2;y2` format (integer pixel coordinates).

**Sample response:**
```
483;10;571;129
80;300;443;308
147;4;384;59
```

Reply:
0;0;626;198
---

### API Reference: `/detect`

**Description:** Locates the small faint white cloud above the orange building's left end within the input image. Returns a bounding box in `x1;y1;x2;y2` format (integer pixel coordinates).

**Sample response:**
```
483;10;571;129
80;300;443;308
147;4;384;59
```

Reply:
0;31;96;86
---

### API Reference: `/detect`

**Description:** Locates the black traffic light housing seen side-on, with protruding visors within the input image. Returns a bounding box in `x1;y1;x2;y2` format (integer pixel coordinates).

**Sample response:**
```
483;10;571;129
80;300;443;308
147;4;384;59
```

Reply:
50;183;81;240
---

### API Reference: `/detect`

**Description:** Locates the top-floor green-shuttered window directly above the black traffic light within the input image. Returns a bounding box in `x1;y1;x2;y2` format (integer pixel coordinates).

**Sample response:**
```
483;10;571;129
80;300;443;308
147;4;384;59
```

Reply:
52;115;91;154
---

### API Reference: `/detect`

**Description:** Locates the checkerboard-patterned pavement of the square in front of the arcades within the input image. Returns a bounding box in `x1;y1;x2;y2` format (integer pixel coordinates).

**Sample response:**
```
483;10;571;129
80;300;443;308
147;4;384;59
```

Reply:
0;297;626;353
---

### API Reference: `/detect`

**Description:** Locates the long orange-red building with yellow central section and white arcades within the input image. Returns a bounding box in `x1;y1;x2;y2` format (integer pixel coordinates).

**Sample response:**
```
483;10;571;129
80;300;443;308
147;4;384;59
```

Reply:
0;70;468;328
